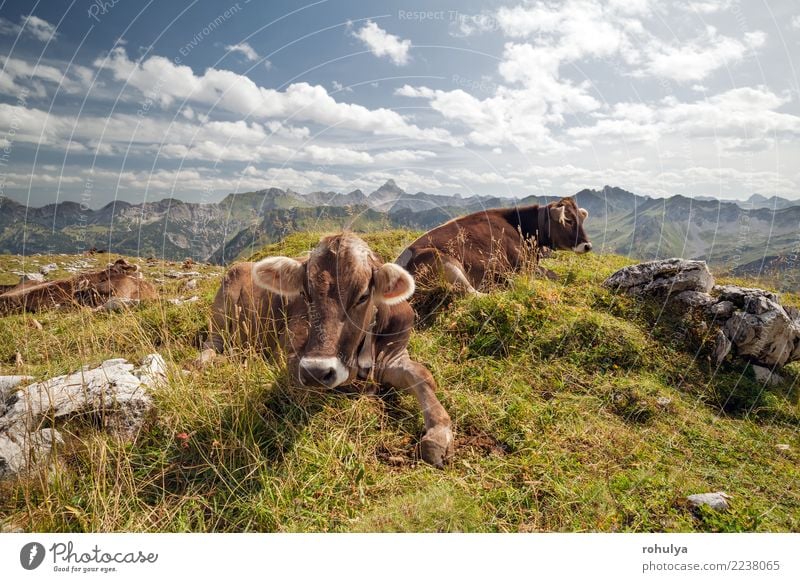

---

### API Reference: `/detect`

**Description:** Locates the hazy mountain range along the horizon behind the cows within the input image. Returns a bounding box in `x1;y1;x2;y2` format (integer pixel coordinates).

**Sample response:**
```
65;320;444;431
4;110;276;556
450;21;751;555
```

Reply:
0;180;800;284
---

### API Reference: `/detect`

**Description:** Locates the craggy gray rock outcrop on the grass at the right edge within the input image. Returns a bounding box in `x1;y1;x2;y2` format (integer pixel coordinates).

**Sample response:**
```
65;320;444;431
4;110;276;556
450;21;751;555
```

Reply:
603;259;800;374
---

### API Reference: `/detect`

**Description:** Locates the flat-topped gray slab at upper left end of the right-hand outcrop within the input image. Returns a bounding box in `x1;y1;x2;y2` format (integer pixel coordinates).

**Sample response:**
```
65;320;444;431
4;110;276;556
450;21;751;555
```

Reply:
603;259;714;297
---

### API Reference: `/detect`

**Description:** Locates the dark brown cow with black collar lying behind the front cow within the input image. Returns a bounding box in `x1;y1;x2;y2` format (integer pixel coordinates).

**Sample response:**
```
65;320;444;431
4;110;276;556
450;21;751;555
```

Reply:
395;198;592;294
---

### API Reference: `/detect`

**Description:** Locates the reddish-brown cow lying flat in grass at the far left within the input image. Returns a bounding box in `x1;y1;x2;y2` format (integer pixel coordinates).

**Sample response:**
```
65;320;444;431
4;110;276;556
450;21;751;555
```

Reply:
0;259;157;314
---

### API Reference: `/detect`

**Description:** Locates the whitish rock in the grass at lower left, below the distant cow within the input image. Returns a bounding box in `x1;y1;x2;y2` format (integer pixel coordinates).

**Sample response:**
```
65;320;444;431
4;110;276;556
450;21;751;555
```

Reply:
0;354;166;478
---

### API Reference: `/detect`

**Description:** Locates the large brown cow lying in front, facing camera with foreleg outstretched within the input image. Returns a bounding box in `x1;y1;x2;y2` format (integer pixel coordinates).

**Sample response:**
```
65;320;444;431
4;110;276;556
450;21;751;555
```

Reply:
198;233;453;467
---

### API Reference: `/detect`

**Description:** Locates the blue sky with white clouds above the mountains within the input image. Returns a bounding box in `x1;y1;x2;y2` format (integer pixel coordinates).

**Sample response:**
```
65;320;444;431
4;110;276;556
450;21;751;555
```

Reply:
0;0;800;208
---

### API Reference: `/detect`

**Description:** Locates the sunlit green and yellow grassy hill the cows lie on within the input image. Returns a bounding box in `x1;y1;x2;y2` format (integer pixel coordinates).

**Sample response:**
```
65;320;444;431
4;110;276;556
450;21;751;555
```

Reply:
0;231;800;532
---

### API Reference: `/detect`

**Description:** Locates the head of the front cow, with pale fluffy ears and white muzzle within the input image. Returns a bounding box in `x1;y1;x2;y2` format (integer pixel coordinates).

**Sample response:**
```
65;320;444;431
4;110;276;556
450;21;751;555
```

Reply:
253;233;414;388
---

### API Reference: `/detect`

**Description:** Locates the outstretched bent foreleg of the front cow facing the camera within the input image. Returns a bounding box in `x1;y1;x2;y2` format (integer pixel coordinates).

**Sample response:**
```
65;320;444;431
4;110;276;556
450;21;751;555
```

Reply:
381;355;453;469
